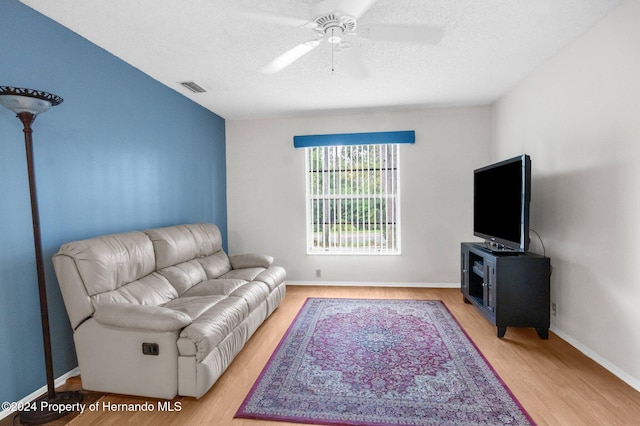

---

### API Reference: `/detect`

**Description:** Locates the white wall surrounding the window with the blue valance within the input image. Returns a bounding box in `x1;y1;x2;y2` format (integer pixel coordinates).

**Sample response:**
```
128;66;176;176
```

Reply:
226;107;492;285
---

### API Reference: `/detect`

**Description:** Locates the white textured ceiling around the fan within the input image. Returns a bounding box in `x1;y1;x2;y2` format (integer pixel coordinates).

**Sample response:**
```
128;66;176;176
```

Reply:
21;0;622;119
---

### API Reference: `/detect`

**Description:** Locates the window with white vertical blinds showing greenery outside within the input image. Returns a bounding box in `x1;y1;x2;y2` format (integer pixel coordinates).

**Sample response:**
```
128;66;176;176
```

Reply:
305;144;400;254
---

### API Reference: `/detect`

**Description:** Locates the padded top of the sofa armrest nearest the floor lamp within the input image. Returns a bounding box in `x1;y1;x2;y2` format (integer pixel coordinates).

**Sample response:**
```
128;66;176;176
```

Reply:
93;303;193;331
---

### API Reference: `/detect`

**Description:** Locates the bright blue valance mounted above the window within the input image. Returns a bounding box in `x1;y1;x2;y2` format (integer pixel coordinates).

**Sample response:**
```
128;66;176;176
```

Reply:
293;130;416;148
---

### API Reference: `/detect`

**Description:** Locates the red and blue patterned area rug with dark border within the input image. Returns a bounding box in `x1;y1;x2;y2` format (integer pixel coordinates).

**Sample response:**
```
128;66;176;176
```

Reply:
236;298;533;425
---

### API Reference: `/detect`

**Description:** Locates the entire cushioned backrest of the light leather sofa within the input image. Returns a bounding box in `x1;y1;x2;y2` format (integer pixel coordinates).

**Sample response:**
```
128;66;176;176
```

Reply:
53;224;231;329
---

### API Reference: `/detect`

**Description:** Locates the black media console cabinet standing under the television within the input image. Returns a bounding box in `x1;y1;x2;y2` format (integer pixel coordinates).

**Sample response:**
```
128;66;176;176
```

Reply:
460;243;551;339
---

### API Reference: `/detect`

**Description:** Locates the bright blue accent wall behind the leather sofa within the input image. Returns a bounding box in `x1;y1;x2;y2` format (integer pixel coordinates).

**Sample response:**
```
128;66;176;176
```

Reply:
0;0;227;401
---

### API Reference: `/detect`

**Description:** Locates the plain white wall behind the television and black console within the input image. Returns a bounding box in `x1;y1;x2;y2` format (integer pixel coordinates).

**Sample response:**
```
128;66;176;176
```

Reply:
494;0;640;389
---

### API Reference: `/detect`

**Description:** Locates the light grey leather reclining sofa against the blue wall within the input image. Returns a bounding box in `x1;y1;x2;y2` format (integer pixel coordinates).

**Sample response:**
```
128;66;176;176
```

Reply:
53;224;285;399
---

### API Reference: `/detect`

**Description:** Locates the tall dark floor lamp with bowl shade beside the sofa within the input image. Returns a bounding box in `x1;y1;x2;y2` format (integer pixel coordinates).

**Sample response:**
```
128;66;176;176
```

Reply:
0;86;82;424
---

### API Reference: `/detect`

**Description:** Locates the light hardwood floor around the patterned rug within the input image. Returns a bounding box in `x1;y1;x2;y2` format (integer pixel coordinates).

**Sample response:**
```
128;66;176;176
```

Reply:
40;286;640;426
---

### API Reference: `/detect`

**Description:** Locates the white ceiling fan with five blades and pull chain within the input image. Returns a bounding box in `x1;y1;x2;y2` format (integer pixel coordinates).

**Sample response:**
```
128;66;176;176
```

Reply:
238;0;444;77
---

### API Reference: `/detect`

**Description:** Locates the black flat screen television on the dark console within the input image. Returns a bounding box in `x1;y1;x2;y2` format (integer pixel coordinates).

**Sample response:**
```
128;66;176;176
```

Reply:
473;154;531;252
